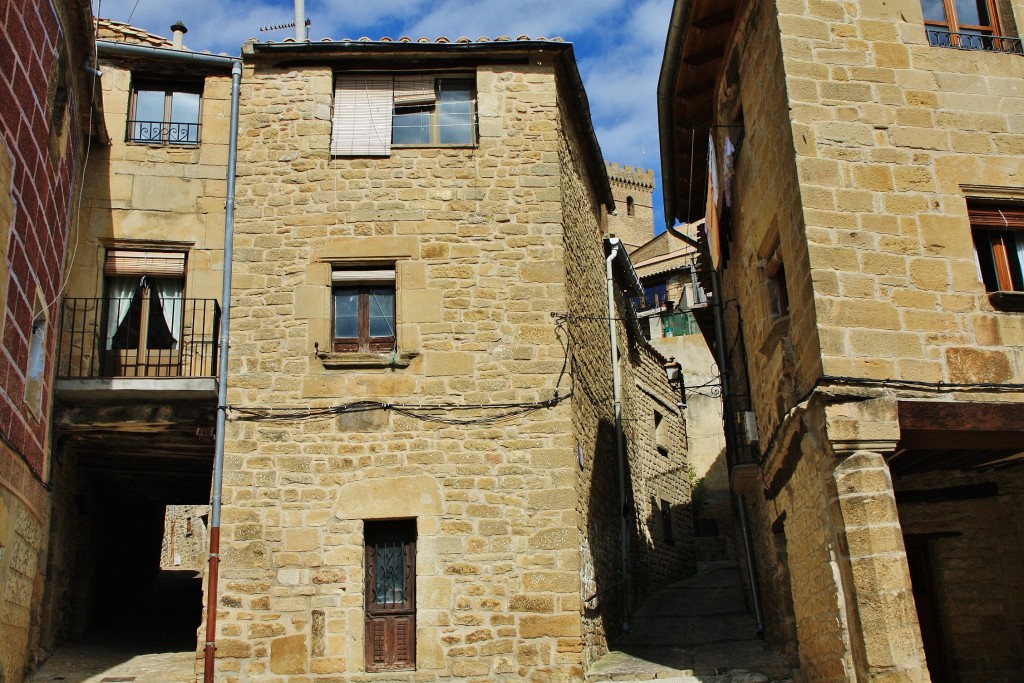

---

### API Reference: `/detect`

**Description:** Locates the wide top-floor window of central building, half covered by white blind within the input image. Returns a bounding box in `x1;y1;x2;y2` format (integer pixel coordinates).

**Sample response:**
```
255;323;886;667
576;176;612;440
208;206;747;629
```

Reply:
331;74;476;157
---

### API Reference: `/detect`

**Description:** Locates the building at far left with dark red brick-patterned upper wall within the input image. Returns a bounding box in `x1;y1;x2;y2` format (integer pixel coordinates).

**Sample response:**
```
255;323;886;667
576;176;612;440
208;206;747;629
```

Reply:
0;0;101;681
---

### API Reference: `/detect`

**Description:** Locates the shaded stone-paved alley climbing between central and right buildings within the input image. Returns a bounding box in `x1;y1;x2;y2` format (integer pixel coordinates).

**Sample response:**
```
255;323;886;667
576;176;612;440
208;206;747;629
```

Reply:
587;561;793;683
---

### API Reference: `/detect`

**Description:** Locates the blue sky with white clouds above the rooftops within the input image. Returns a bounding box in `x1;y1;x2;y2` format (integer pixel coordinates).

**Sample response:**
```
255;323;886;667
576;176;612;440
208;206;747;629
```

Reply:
92;0;673;231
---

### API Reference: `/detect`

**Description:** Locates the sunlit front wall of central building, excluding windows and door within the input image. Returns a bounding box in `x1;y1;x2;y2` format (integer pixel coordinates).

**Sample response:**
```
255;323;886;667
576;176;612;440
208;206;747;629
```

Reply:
218;50;585;681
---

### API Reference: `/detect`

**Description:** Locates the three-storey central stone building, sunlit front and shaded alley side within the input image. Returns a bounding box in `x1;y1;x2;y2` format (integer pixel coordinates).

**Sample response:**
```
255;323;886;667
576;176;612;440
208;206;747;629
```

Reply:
203;38;692;681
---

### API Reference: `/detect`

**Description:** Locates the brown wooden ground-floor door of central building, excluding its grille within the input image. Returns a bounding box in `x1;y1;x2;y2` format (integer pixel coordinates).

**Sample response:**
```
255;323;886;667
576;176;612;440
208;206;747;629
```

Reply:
364;519;417;673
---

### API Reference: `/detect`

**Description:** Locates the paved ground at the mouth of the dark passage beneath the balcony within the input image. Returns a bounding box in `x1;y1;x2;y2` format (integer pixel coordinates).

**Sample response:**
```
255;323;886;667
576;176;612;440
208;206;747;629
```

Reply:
29;643;196;683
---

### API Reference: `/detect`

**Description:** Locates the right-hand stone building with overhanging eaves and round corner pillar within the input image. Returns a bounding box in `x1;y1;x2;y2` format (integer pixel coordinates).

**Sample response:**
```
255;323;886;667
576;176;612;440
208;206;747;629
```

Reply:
658;0;1024;681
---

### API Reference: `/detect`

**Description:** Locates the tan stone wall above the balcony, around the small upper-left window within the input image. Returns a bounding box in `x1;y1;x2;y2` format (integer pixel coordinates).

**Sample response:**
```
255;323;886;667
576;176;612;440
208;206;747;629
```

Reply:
68;57;231;299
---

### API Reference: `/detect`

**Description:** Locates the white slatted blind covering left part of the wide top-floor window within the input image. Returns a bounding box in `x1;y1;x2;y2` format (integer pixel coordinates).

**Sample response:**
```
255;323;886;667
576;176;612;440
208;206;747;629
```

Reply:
331;75;394;157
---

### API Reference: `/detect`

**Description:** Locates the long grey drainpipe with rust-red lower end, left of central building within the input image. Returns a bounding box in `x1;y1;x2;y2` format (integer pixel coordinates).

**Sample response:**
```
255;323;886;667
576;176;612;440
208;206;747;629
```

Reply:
203;59;242;683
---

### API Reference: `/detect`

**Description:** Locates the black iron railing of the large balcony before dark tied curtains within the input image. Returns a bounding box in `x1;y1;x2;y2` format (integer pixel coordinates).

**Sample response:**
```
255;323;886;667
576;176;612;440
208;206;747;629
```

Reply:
56;298;220;379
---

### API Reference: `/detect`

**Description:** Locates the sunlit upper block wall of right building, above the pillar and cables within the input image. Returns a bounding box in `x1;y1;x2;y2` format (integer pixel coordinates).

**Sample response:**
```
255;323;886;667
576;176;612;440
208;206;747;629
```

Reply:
779;0;1024;383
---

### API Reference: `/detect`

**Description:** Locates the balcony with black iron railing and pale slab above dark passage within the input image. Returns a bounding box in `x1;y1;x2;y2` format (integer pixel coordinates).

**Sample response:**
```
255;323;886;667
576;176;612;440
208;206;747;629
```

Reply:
56;298;220;399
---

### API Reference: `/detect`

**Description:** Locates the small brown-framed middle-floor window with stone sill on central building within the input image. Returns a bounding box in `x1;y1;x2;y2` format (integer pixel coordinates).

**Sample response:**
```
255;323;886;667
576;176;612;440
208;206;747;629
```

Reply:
331;265;397;353
